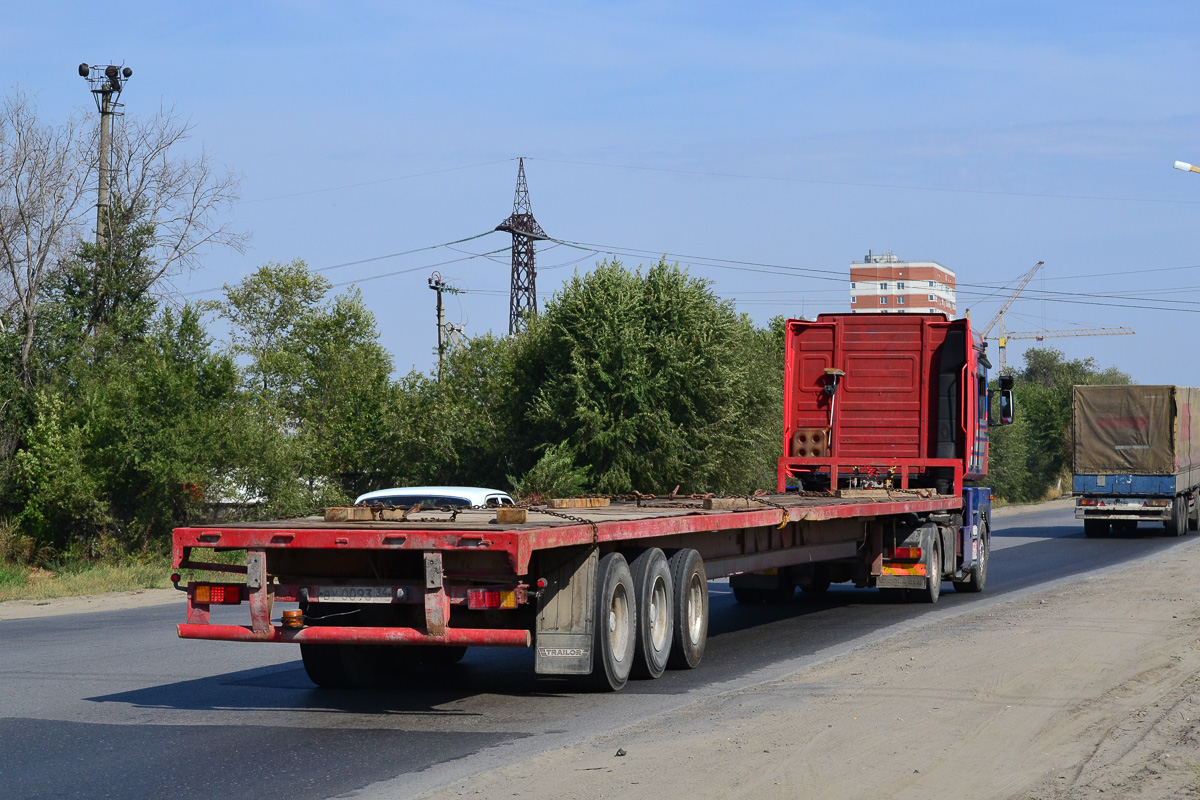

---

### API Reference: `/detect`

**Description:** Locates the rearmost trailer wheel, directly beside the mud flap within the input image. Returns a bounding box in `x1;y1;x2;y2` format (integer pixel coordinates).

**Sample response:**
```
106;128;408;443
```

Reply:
592;553;637;692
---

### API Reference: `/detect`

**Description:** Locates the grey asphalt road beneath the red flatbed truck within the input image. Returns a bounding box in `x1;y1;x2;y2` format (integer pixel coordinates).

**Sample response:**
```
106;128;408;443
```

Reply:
0;505;1196;800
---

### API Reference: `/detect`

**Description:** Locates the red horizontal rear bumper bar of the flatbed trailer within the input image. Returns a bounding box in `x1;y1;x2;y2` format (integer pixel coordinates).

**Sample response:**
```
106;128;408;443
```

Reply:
176;622;532;648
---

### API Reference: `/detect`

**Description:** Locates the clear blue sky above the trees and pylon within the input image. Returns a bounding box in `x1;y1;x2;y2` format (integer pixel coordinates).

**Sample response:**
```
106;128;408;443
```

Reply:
7;0;1200;386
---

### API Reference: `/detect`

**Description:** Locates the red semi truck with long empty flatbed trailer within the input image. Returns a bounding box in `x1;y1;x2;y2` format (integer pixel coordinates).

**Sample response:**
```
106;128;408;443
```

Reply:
173;314;1012;690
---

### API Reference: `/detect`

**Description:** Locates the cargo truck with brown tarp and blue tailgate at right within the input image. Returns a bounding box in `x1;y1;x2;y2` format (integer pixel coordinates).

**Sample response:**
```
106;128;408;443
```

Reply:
1072;386;1200;537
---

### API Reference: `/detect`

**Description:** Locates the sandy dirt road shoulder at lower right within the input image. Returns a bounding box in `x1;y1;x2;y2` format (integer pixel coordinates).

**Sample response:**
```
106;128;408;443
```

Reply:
410;539;1200;800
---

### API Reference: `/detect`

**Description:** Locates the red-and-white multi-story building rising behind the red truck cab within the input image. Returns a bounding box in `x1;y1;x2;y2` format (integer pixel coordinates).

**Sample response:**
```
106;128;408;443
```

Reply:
850;253;955;318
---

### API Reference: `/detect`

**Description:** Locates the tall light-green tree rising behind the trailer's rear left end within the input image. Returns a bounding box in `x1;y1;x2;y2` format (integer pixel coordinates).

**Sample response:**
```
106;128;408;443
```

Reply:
220;260;394;513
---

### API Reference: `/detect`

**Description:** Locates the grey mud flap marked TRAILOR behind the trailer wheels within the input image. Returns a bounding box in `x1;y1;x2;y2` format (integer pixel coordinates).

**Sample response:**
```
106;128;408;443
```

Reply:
534;546;600;675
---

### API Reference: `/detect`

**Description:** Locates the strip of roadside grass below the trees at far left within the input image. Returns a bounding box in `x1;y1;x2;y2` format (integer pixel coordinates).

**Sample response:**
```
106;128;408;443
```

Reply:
0;549;246;602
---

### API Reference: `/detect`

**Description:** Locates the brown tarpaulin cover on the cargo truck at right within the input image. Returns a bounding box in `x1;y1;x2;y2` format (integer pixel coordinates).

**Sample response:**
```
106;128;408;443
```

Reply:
1073;386;1200;475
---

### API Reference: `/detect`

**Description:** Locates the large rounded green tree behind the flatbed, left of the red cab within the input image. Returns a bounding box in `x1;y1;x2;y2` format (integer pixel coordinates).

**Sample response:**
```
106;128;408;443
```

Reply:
514;259;782;493
